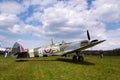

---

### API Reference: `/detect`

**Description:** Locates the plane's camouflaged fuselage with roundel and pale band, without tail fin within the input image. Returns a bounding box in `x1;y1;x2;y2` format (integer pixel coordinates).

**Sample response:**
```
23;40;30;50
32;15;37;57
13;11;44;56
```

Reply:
28;40;88;57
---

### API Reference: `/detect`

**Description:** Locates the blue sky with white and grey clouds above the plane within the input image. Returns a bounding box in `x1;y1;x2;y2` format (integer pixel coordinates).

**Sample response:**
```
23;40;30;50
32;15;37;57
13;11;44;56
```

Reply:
0;0;120;50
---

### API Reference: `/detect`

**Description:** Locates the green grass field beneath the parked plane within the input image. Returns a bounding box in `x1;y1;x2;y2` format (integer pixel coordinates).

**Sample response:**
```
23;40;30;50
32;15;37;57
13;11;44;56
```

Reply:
0;56;120;80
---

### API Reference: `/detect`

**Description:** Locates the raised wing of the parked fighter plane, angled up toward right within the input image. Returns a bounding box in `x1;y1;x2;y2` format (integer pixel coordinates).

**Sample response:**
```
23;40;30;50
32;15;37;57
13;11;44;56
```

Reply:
63;40;106;55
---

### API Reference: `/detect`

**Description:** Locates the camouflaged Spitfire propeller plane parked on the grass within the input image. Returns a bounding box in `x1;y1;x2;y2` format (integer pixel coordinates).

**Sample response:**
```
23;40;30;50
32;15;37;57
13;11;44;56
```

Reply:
11;30;105;62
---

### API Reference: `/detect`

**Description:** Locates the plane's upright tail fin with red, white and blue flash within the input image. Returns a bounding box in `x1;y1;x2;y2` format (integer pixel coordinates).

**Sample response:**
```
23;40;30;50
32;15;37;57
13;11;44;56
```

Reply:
11;42;25;58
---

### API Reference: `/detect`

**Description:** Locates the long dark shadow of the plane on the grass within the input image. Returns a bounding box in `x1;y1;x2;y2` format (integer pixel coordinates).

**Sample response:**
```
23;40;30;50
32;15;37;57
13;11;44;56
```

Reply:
16;58;95;65
